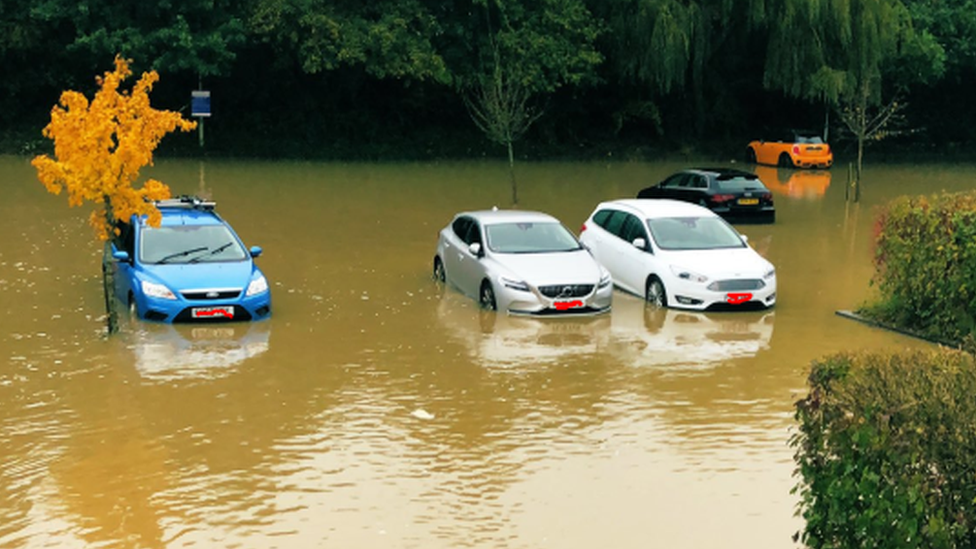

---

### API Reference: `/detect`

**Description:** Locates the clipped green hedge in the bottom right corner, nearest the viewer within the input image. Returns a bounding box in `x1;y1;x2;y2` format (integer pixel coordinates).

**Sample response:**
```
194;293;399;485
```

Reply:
791;350;976;549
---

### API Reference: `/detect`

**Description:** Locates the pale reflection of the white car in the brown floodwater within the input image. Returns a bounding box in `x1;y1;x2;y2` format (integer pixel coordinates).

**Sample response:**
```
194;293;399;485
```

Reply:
610;292;775;370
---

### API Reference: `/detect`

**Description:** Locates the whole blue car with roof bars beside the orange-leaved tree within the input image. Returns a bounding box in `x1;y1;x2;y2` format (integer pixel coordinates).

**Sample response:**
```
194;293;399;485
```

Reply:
112;197;271;322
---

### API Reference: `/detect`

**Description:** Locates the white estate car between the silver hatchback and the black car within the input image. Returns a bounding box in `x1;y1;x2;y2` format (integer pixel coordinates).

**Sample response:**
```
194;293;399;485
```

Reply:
580;199;776;311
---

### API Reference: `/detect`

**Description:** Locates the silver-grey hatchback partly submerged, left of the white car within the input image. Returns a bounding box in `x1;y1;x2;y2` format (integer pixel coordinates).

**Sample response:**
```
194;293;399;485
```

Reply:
434;210;613;315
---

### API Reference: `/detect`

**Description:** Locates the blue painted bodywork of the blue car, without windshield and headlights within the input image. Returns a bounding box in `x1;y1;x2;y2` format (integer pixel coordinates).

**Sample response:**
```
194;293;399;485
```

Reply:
112;200;271;322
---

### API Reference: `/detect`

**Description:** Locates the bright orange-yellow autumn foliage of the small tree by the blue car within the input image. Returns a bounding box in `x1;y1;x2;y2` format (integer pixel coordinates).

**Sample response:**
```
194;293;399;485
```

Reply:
32;56;196;240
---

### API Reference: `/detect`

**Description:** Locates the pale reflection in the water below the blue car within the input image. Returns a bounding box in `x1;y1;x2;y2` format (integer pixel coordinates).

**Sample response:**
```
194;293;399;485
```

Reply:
128;321;271;381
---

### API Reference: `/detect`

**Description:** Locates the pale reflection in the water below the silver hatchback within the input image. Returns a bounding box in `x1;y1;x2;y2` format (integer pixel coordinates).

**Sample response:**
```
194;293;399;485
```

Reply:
437;291;618;368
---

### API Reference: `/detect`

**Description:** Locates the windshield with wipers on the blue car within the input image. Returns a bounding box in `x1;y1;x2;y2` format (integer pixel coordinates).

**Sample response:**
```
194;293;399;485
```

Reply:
139;225;248;263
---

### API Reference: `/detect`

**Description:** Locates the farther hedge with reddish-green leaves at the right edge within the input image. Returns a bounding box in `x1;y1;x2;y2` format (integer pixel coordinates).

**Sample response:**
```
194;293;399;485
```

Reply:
861;192;976;343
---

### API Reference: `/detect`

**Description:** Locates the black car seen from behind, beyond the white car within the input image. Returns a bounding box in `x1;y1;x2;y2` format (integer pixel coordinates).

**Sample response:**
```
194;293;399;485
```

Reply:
637;168;776;222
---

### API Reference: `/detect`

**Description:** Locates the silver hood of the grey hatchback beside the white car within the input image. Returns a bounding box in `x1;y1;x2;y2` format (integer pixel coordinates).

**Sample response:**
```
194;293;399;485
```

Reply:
494;250;600;286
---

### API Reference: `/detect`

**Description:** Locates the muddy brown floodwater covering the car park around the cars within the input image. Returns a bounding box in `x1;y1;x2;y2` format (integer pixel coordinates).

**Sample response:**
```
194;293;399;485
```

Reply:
0;157;976;549
